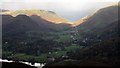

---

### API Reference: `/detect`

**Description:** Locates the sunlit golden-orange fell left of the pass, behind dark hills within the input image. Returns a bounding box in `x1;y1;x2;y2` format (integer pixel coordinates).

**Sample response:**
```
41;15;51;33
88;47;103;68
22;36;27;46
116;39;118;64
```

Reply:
0;9;72;24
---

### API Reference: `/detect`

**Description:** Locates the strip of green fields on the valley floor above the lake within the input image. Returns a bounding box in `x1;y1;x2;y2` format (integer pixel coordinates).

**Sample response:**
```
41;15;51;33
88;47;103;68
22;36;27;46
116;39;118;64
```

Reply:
3;44;80;62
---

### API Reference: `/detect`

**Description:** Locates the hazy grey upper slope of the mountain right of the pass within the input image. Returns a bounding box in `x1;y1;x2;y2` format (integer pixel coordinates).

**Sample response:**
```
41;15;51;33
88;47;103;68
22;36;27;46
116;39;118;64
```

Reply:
79;5;119;30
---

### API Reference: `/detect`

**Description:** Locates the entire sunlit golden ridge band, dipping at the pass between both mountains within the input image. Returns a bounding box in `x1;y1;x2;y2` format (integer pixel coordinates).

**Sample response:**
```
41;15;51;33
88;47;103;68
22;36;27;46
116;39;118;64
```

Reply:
0;5;119;27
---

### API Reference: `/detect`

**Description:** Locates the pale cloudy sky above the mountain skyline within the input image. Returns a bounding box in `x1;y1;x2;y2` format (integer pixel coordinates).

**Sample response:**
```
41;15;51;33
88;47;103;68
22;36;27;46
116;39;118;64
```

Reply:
0;0;119;21
